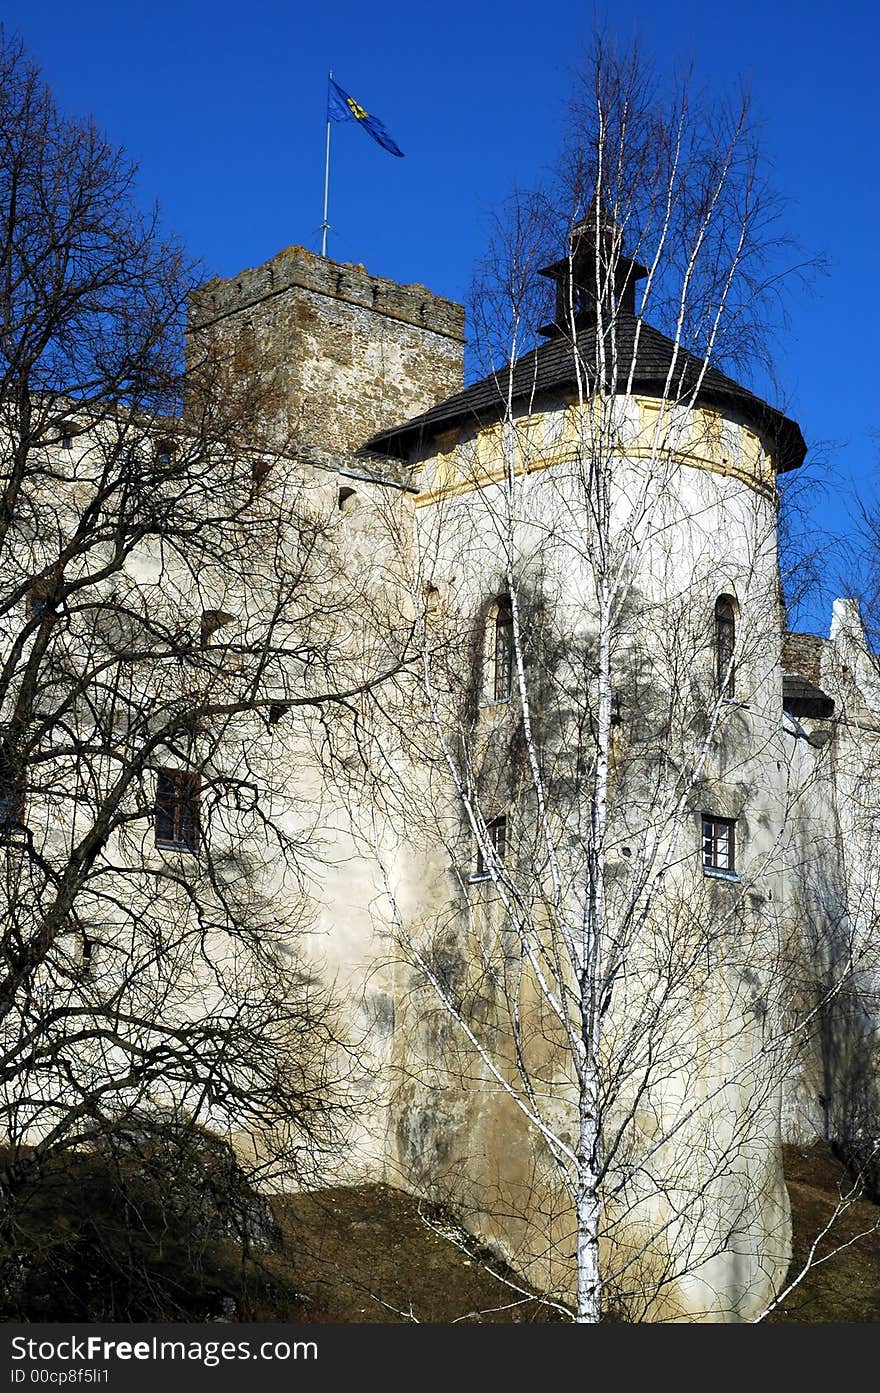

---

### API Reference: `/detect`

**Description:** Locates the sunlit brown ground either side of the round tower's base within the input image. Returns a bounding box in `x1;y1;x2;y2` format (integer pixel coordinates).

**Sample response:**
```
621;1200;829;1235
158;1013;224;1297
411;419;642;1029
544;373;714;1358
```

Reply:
243;1146;880;1323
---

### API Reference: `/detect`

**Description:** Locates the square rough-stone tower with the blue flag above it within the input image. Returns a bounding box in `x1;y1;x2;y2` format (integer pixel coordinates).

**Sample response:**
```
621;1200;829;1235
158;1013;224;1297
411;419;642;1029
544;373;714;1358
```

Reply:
188;247;465;453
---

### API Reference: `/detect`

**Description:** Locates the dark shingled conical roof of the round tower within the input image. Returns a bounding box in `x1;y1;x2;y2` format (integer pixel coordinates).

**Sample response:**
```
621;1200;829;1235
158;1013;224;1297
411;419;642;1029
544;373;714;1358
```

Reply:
365;315;806;471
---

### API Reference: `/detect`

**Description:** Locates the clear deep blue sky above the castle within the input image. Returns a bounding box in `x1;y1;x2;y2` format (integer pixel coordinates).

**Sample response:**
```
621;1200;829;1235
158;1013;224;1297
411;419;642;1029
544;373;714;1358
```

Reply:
3;0;880;630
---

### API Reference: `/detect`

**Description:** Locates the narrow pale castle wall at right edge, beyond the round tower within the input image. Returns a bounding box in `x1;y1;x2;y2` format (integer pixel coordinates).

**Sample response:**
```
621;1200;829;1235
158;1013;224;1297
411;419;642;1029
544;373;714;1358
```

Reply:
783;600;880;1158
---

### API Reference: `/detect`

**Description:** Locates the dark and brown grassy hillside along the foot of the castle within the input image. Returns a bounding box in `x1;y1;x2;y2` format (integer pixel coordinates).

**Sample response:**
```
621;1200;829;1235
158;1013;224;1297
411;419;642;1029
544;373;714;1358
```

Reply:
0;1139;880;1323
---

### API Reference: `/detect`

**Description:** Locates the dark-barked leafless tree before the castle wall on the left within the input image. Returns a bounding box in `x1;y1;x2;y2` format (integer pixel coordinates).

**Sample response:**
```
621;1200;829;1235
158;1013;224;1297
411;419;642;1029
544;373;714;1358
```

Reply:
0;29;400;1242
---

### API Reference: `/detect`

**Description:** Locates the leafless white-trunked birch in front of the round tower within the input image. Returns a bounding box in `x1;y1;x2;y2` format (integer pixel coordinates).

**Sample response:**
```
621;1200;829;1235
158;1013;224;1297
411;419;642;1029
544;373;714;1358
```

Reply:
343;46;841;1321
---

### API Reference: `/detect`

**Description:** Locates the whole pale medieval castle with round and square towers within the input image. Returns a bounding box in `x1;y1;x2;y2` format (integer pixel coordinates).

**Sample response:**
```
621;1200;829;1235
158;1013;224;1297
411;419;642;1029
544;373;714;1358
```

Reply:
4;227;880;1321
